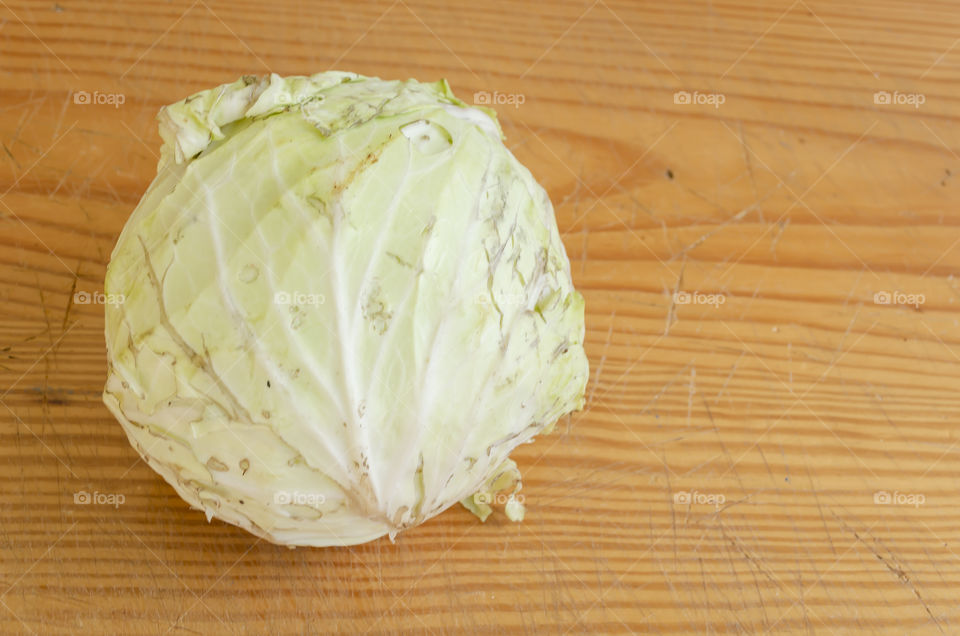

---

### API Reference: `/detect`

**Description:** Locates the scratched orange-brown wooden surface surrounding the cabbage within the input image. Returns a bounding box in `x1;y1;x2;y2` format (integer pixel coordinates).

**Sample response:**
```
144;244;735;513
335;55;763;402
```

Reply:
0;0;960;634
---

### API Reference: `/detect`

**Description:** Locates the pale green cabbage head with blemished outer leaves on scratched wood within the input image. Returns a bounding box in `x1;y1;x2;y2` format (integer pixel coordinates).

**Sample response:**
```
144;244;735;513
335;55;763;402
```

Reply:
104;72;587;546
